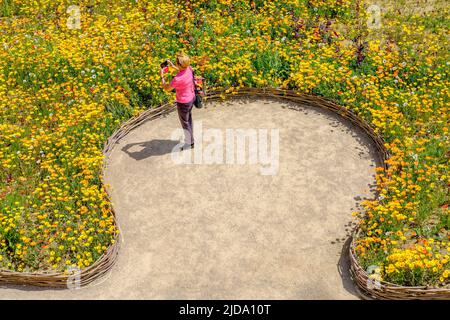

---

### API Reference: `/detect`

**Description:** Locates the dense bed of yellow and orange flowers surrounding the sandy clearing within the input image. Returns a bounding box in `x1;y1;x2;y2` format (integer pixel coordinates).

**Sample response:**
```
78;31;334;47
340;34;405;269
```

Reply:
0;0;450;286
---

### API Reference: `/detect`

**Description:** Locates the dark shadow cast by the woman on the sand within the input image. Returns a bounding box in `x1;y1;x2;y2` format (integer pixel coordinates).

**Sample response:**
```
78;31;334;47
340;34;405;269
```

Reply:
122;139;180;160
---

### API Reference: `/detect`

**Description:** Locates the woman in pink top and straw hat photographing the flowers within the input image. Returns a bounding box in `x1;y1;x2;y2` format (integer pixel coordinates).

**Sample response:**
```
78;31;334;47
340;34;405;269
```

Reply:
161;54;195;149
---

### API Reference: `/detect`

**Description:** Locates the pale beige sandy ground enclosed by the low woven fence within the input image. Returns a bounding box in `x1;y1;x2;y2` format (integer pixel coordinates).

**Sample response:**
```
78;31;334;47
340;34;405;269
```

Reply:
0;99;382;299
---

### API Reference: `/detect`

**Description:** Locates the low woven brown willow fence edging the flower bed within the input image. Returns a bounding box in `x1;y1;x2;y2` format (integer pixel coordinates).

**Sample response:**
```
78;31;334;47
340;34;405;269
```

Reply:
0;88;450;299
